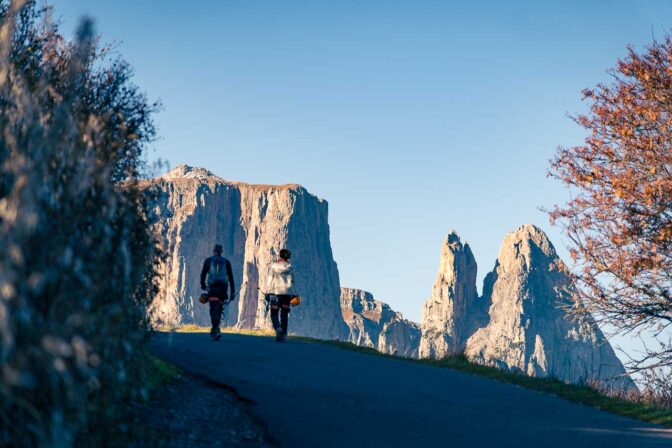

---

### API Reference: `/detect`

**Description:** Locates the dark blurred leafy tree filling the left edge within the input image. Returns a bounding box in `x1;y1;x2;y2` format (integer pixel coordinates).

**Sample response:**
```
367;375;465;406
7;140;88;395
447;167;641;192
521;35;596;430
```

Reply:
0;0;157;446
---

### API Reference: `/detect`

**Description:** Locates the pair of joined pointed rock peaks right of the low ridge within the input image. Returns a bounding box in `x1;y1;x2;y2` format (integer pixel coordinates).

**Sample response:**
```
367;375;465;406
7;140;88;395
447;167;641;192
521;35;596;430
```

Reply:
420;225;635;390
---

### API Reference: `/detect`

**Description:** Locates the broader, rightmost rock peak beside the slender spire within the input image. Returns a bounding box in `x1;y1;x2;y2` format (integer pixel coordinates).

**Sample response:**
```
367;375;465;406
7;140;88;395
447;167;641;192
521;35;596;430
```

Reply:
465;225;635;389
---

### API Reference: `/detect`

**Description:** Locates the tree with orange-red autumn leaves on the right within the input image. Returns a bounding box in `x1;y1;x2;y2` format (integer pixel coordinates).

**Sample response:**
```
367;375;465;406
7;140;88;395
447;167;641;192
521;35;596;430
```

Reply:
549;32;672;370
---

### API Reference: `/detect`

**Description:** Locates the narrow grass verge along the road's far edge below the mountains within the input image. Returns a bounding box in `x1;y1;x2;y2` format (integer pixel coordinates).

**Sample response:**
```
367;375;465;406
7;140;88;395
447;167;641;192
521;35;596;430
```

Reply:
161;325;672;428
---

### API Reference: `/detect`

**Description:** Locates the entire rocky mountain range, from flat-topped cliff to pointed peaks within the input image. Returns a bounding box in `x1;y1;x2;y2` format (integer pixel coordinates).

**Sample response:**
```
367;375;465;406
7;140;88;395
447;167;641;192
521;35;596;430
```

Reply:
141;165;634;389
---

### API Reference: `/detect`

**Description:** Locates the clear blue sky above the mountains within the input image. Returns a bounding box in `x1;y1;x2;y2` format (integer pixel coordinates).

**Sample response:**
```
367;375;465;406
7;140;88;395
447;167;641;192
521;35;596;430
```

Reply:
52;0;672;332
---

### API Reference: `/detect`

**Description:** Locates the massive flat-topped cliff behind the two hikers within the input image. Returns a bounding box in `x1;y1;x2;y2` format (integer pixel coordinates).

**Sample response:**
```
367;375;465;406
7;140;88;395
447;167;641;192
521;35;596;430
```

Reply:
142;165;347;338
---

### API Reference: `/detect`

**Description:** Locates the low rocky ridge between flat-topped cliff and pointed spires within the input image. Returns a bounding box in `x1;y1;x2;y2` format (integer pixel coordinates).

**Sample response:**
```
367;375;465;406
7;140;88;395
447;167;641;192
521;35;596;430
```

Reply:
341;288;420;358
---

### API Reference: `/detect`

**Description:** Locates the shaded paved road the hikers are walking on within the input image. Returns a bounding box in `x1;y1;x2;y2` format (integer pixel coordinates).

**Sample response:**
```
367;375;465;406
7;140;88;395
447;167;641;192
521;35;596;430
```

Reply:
152;333;672;448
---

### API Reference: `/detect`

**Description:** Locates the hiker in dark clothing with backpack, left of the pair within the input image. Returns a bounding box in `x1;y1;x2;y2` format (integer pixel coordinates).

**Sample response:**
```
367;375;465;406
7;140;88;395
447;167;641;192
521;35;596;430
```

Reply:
201;244;236;341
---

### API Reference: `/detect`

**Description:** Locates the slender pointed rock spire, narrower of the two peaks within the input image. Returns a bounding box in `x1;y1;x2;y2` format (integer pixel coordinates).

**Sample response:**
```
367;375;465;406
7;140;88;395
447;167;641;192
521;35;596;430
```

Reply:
420;231;487;358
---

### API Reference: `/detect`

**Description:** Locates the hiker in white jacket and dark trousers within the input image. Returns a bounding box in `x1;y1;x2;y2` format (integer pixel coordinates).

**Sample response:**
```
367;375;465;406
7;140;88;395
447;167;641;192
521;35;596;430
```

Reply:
266;249;296;342
